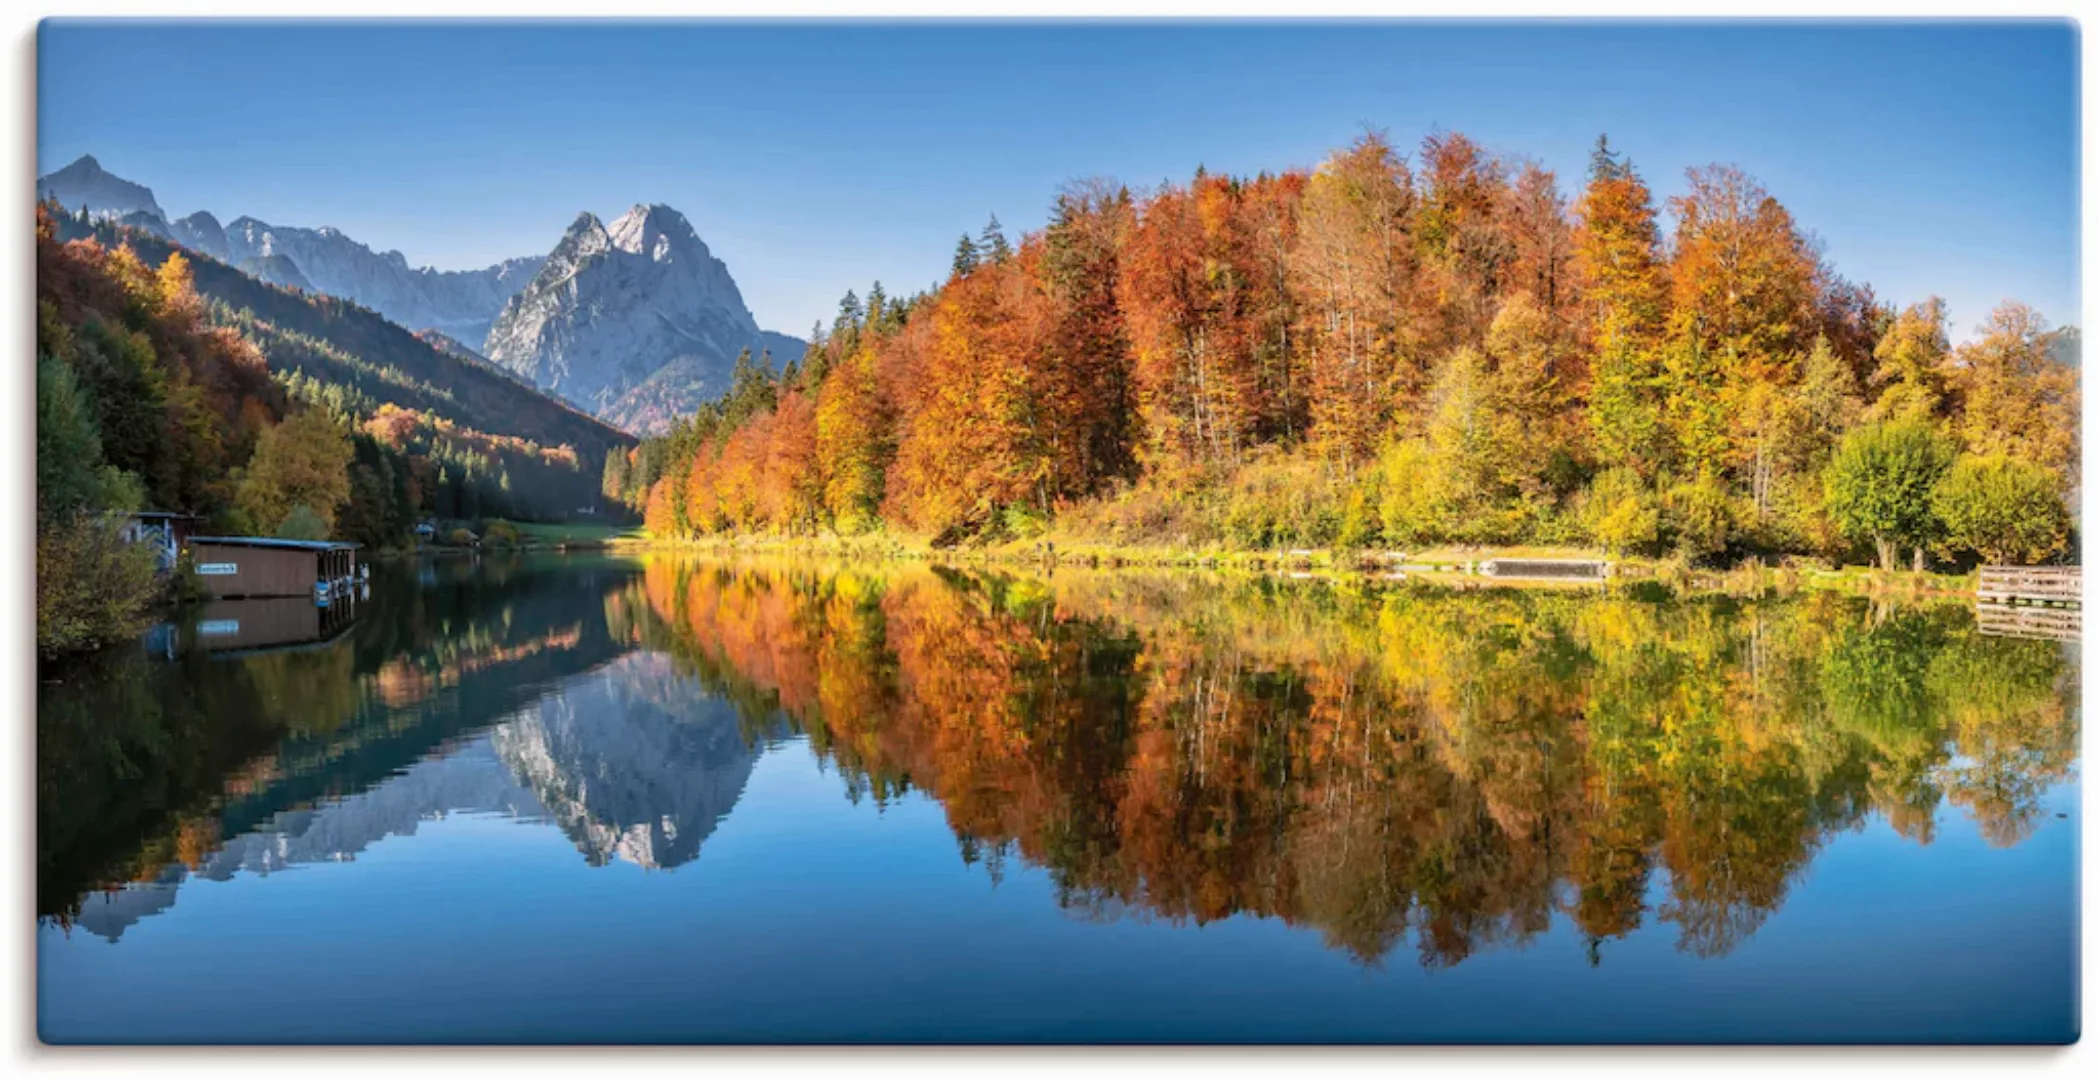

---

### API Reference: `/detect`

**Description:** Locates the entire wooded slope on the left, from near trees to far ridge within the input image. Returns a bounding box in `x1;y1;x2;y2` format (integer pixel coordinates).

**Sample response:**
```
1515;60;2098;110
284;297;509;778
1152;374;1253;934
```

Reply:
36;206;632;656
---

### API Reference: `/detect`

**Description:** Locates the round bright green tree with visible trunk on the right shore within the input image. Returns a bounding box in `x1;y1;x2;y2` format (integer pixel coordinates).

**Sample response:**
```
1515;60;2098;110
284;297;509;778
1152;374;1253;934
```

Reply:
1822;419;1954;570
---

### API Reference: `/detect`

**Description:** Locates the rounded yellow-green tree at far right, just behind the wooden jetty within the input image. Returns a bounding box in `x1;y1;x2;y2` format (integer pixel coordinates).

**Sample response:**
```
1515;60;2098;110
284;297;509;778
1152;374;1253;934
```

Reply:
1931;455;2070;564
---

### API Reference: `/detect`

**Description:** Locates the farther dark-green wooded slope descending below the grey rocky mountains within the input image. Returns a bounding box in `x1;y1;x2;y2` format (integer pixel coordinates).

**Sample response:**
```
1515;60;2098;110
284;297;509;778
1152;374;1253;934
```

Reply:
57;208;634;518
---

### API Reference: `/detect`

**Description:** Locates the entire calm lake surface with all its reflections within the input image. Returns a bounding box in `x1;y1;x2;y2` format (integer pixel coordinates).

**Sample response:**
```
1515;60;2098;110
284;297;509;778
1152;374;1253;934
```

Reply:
38;556;2080;1042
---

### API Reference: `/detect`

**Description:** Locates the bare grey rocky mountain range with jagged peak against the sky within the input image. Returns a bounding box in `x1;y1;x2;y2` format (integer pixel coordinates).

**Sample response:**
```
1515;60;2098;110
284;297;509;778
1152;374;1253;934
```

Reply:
38;157;806;434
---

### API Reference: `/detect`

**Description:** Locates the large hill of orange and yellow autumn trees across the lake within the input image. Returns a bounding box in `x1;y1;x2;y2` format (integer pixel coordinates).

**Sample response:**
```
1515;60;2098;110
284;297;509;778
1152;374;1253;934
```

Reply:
605;134;2078;566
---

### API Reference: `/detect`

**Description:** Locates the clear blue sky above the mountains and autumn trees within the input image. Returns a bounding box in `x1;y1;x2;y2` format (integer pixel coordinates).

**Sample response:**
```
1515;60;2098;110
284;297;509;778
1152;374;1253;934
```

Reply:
38;21;2078;338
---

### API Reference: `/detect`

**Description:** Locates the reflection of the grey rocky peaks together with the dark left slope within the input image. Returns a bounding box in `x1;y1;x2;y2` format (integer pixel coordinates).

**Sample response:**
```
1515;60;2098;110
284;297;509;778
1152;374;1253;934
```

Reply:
40;568;789;939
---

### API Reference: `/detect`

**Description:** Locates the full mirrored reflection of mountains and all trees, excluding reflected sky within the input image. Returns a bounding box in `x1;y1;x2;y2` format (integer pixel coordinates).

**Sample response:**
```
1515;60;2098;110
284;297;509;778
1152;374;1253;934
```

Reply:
38;558;2076;967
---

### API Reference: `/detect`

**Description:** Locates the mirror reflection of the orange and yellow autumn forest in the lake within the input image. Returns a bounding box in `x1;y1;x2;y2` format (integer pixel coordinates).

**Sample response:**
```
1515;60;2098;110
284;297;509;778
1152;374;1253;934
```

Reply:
628;558;2078;967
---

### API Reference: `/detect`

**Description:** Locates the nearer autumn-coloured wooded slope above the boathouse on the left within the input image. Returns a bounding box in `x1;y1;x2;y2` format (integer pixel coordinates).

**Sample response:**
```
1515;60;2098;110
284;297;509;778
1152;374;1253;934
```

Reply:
36;210;314;656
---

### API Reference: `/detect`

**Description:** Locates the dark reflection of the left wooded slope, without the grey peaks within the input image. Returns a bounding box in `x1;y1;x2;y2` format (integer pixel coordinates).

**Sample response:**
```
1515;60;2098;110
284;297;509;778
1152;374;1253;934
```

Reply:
38;560;632;929
